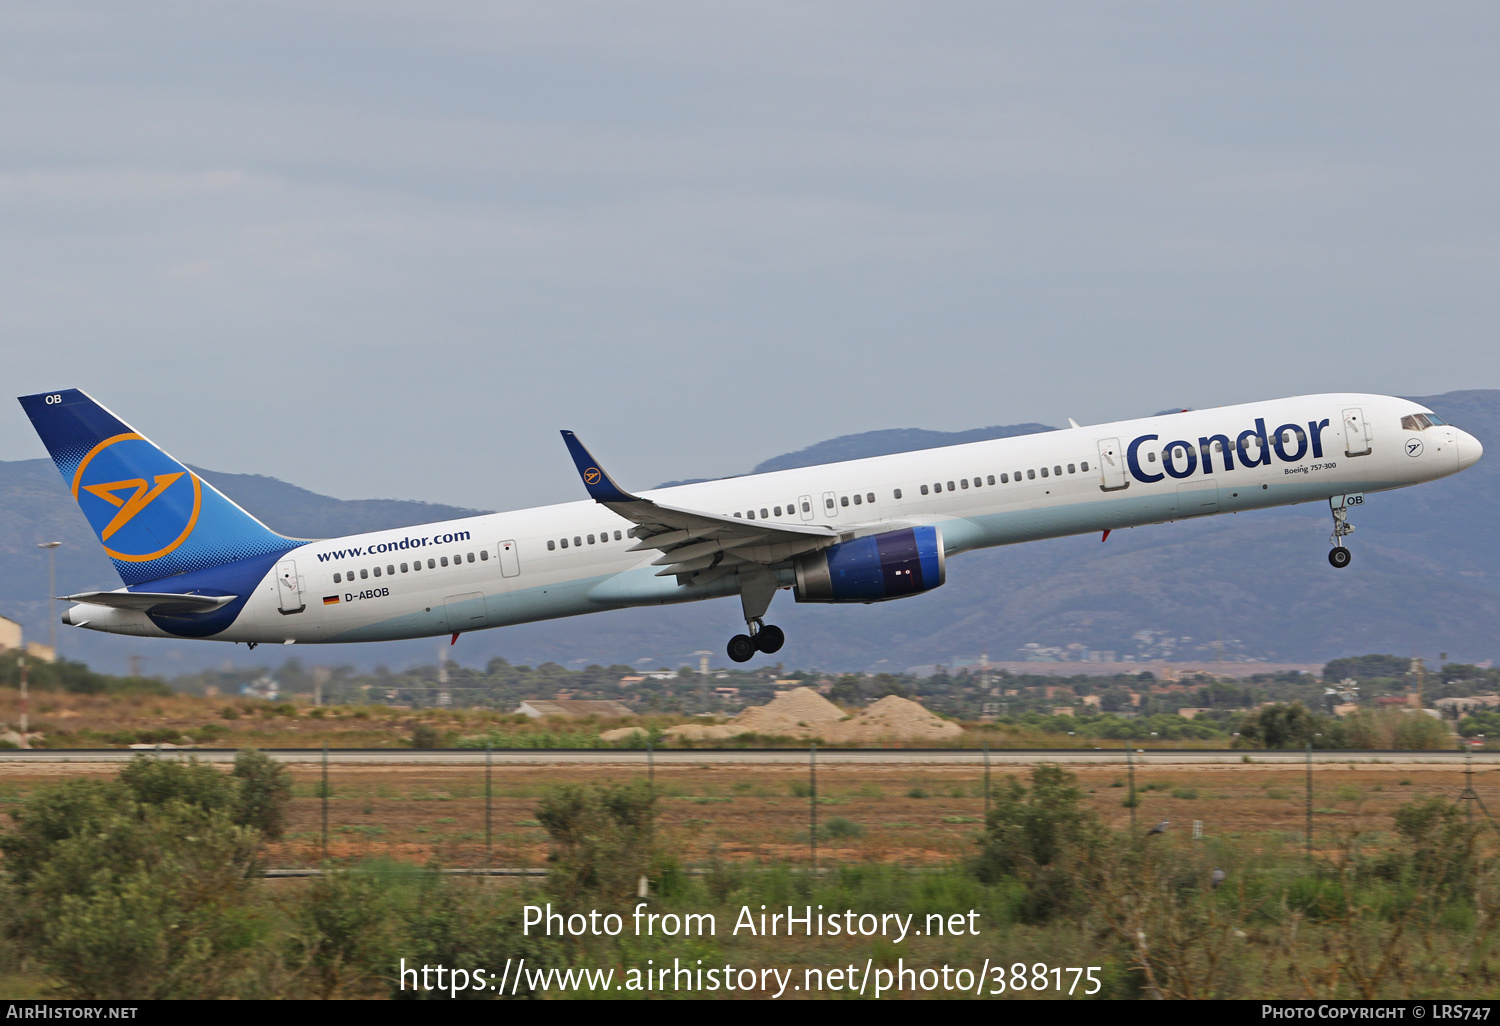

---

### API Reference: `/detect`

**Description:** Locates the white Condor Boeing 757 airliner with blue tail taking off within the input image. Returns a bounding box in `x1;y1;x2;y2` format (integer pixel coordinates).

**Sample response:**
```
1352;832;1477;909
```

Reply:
21;390;1482;662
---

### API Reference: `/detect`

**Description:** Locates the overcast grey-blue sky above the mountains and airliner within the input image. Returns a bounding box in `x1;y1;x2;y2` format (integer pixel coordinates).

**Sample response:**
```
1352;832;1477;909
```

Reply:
0;0;1500;510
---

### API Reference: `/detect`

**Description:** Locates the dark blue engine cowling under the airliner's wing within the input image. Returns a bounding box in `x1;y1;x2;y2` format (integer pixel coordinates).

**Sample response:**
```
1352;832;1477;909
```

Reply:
795;527;948;602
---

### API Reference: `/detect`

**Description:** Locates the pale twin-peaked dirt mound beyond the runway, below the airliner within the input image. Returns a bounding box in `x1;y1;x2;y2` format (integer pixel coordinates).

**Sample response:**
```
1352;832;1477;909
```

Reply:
665;687;963;744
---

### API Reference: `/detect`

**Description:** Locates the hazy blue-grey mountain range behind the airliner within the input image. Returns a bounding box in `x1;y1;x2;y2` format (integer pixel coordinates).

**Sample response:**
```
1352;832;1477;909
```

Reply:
0;390;1500;675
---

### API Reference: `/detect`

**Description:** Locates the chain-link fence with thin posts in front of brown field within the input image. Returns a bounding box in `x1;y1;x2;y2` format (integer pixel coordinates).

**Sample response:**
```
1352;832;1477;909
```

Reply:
0;750;1500;873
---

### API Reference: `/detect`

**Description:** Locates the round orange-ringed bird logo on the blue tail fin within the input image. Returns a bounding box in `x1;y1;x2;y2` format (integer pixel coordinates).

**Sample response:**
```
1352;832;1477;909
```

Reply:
74;432;203;563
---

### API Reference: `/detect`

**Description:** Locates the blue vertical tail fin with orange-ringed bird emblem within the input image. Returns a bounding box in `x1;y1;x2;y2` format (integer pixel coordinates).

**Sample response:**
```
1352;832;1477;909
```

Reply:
21;389;300;585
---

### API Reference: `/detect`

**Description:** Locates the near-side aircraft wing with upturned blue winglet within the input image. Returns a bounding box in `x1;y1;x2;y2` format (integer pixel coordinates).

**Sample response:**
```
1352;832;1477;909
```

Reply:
563;431;839;584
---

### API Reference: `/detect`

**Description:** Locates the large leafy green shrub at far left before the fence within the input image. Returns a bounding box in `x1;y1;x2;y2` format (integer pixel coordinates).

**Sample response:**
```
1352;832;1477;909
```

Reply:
0;780;257;999
